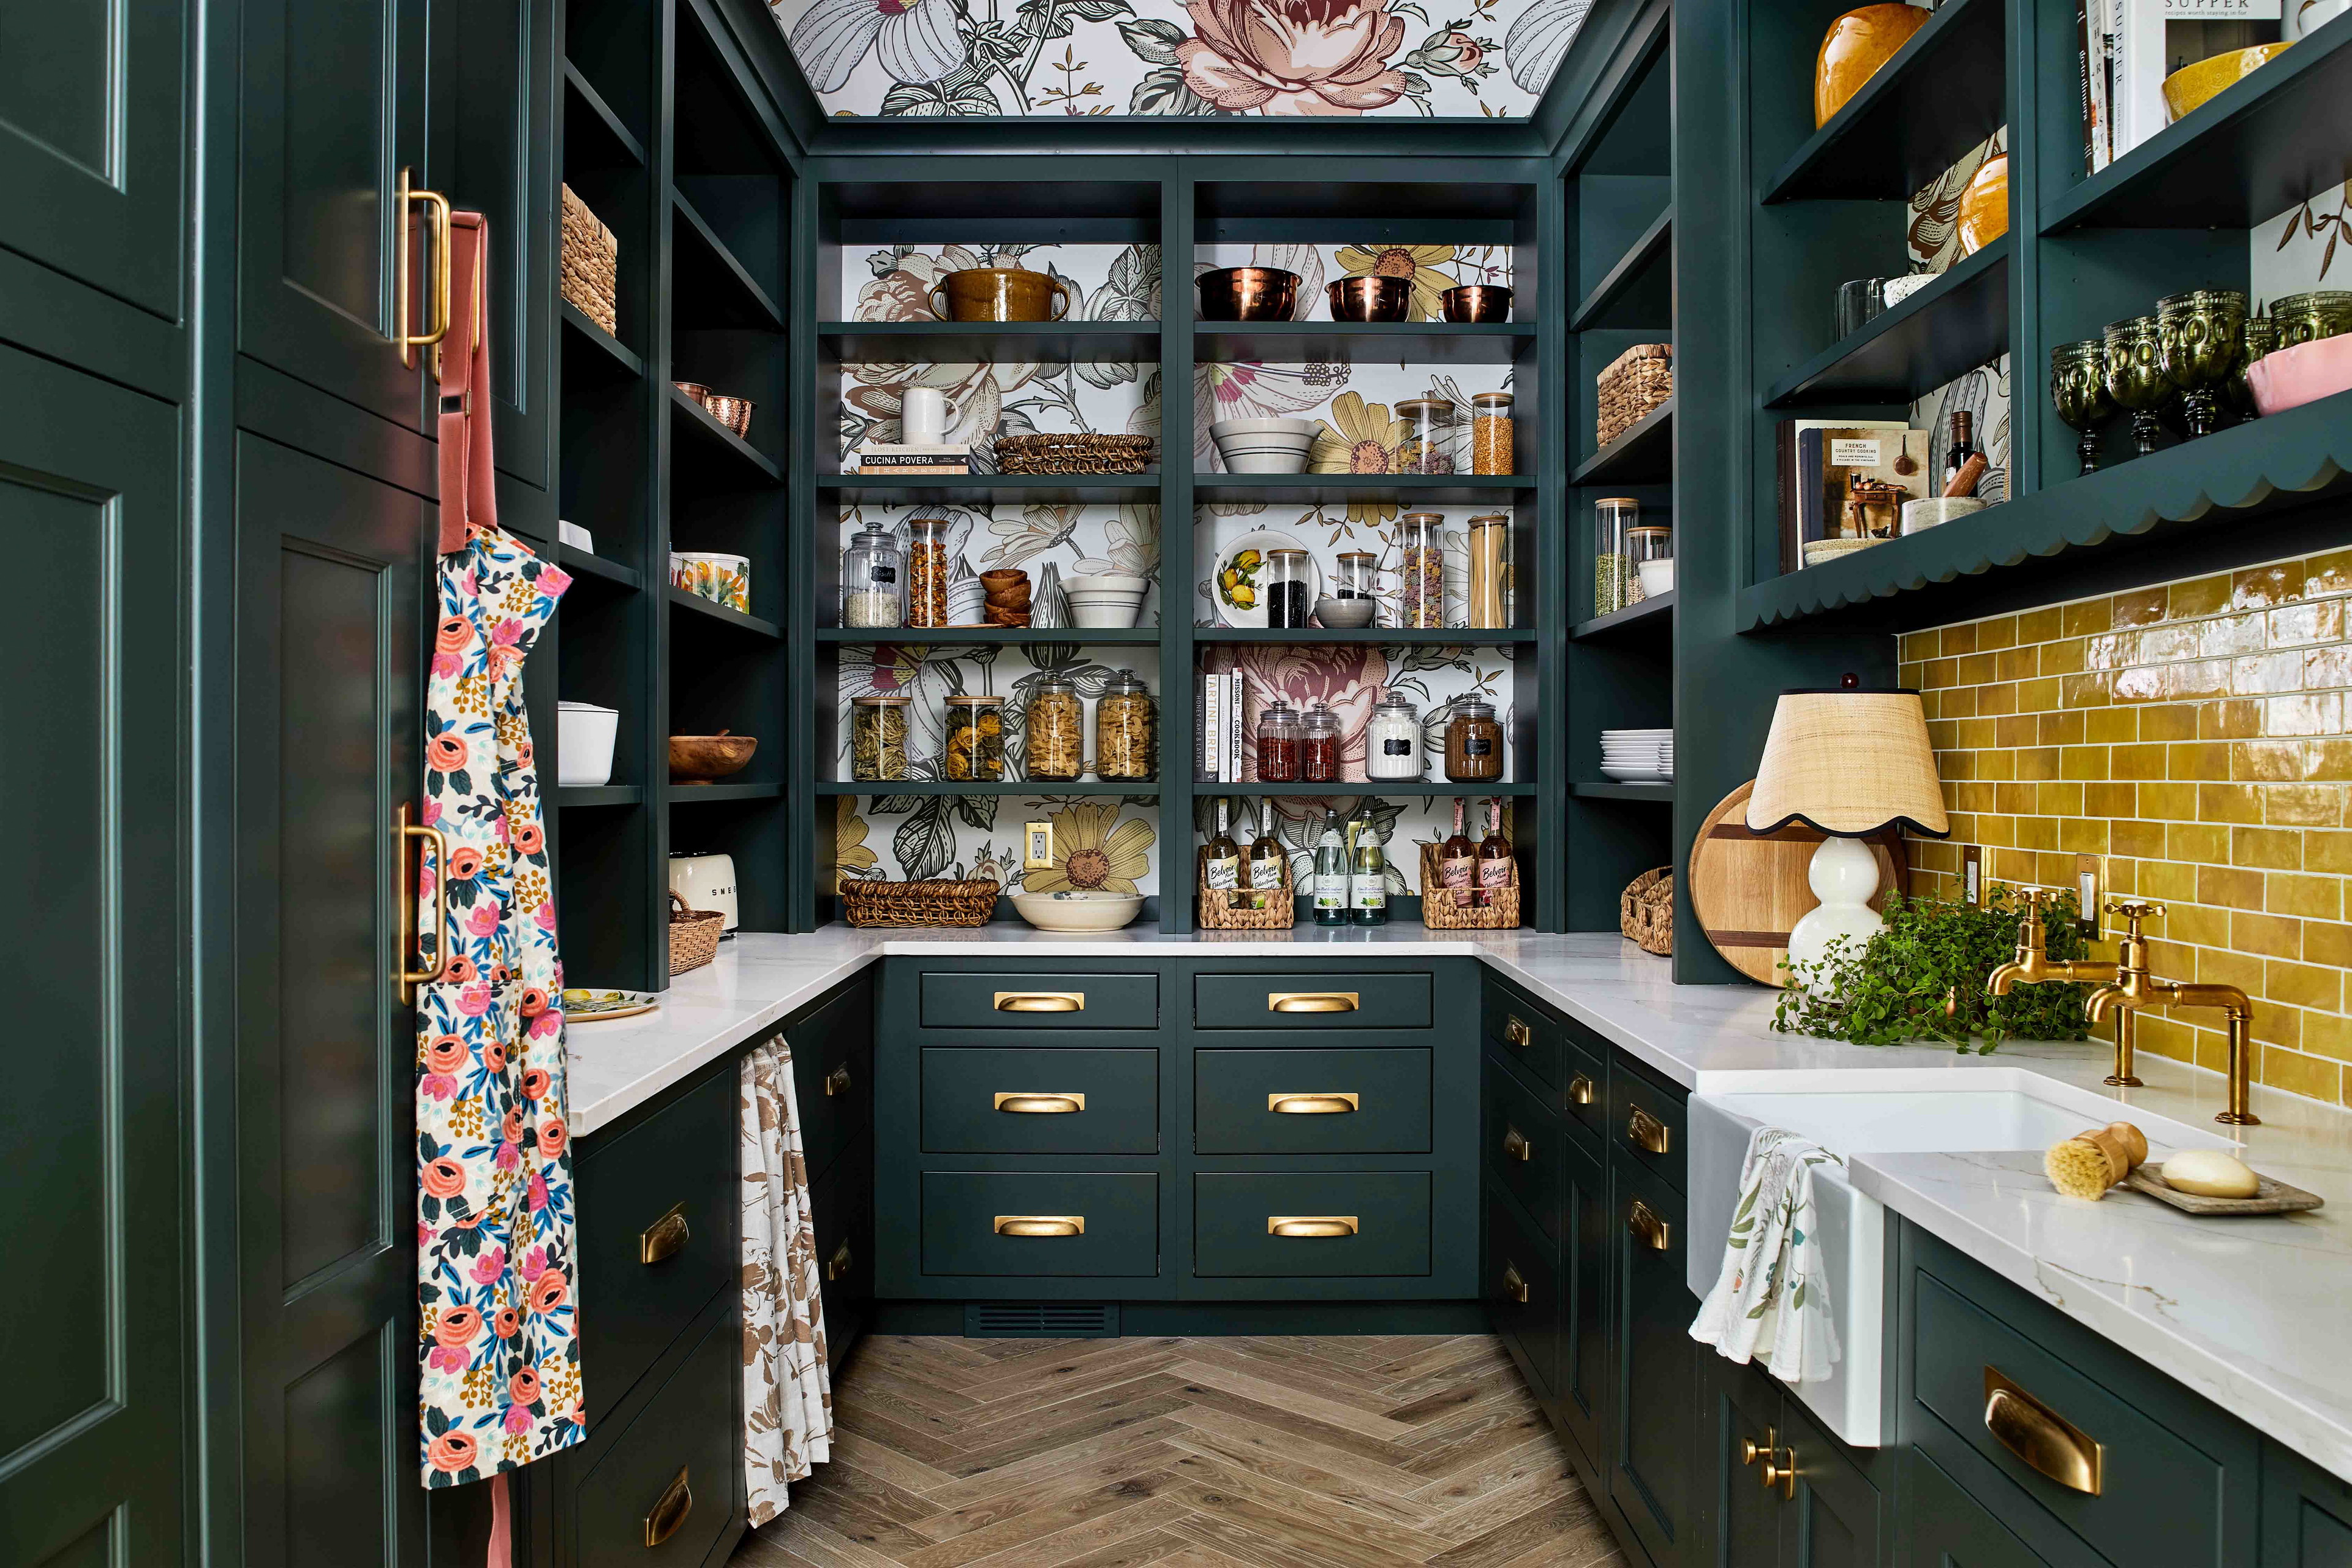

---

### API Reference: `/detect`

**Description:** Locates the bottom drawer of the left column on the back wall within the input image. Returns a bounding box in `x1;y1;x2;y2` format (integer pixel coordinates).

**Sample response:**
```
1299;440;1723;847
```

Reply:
922;1170;1159;1279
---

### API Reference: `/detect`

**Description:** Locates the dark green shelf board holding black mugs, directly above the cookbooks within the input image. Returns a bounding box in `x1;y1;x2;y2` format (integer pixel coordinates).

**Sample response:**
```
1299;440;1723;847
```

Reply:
1764;235;2011;409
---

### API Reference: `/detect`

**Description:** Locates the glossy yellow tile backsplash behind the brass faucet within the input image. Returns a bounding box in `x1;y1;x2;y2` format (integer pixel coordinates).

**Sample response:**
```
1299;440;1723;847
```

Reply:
1898;550;2352;1105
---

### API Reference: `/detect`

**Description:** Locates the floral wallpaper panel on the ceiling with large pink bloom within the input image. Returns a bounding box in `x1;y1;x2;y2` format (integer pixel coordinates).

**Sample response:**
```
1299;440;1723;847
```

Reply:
769;0;1593;120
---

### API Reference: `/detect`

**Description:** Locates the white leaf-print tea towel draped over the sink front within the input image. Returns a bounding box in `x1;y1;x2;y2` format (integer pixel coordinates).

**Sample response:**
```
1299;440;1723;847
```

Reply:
1691;1126;1846;1382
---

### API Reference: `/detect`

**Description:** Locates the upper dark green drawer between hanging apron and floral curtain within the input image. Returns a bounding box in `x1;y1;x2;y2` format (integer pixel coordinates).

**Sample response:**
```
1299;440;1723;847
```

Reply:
576;1069;743;1417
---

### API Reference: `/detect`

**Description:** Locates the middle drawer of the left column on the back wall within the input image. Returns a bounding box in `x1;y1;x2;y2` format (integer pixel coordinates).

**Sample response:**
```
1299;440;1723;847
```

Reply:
922;1046;1159;1154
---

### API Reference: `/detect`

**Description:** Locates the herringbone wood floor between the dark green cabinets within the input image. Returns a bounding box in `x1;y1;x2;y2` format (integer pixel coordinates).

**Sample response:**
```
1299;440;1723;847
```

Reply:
729;1335;1623;1568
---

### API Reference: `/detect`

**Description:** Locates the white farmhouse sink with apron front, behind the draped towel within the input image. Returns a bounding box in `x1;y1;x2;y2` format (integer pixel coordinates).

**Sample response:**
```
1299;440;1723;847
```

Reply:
1686;1067;2234;1448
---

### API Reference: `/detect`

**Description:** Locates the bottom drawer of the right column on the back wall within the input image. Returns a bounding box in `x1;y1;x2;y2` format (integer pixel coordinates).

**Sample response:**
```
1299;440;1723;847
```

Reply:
1193;1170;1430;1279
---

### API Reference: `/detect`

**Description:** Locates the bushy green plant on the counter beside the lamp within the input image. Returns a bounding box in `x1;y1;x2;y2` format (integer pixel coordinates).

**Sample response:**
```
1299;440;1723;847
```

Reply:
1771;886;2089;1055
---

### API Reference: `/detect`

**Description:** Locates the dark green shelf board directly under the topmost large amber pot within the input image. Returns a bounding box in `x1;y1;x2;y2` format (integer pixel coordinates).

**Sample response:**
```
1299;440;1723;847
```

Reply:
1762;0;2003;202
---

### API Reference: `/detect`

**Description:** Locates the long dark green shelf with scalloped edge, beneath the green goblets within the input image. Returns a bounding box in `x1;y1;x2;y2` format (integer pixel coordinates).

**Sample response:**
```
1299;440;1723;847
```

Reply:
1733;393;2352;630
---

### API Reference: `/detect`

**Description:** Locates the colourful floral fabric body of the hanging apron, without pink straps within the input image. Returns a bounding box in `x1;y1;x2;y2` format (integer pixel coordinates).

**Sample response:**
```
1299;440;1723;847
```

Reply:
417;529;586;1486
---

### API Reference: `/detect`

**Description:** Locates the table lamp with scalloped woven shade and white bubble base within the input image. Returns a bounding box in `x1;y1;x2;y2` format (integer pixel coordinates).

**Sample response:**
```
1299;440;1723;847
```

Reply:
1747;675;1952;976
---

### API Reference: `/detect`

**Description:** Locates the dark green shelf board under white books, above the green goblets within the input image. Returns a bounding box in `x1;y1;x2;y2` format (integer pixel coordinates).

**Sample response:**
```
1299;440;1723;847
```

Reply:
2041;17;2352;235
